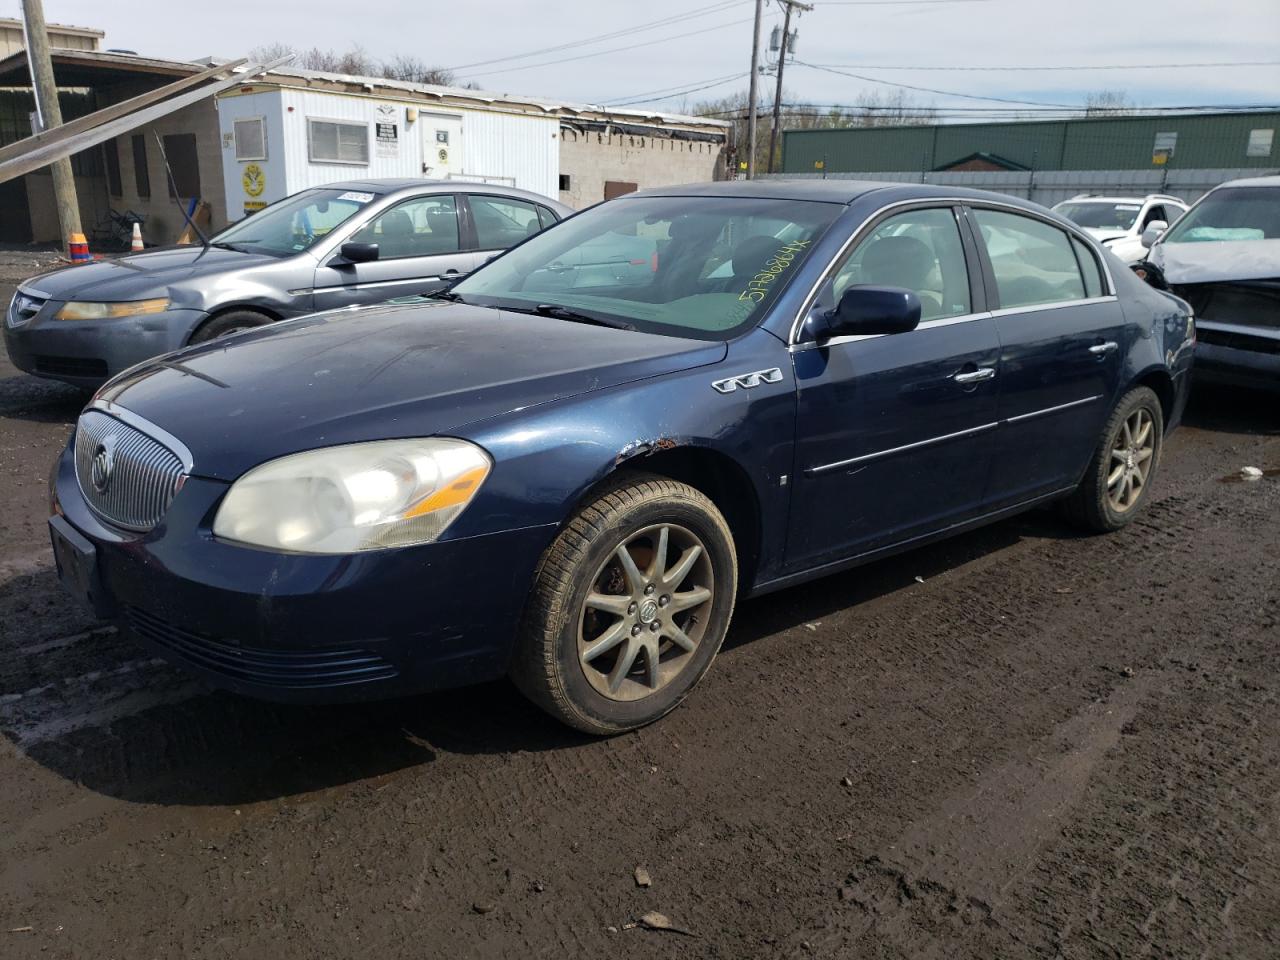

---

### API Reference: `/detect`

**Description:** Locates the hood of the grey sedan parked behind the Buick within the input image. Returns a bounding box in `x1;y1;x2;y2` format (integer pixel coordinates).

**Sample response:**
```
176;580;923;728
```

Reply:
22;246;276;301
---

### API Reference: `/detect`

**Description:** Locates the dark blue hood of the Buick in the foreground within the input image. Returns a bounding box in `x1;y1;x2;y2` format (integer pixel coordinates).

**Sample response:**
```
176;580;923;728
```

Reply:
97;302;727;480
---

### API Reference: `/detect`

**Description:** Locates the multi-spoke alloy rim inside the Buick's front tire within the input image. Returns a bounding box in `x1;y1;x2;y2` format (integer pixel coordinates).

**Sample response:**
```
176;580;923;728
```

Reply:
577;524;714;700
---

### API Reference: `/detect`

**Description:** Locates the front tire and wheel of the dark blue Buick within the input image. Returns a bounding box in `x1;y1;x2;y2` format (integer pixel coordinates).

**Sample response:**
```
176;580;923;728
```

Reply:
511;475;737;735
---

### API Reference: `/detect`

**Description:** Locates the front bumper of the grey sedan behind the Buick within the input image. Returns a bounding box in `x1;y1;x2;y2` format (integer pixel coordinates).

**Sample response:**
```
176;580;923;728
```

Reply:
4;301;207;389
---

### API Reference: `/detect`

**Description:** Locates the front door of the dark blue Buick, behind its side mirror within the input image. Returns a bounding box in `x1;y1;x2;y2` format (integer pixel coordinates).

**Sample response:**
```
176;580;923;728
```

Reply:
787;206;1000;567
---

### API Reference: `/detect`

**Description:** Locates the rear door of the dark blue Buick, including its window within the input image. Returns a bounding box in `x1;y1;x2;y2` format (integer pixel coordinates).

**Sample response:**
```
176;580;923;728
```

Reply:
968;205;1128;508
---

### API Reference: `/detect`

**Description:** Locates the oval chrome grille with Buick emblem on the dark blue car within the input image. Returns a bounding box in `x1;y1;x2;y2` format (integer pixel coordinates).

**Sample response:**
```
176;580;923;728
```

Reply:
76;410;186;531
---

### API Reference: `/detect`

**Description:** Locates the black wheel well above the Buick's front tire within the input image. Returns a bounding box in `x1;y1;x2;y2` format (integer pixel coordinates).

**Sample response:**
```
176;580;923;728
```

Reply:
602;447;760;599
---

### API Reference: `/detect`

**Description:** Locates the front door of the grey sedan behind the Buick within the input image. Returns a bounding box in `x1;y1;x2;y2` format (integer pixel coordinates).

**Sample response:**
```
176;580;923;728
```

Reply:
315;193;477;310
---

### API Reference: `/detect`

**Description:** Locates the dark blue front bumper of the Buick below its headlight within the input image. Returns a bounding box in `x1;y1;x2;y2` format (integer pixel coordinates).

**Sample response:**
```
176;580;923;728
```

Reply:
52;448;556;703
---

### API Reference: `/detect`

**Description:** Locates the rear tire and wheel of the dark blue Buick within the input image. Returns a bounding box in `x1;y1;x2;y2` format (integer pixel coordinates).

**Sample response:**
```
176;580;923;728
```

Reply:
1062;387;1165;534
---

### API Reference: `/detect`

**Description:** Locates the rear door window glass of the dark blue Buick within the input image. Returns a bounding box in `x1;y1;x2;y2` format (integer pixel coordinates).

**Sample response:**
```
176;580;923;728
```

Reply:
973;207;1085;307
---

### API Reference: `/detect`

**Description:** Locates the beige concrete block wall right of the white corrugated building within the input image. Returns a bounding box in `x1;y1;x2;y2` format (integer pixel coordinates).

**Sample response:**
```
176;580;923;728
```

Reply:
559;127;724;209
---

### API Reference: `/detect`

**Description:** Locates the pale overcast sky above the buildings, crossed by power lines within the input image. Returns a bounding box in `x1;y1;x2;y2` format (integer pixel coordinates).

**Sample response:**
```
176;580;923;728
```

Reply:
10;0;1280;110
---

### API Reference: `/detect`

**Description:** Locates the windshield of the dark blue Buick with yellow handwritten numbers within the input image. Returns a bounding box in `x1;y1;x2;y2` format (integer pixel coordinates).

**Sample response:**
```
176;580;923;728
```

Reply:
452;196;844;340
